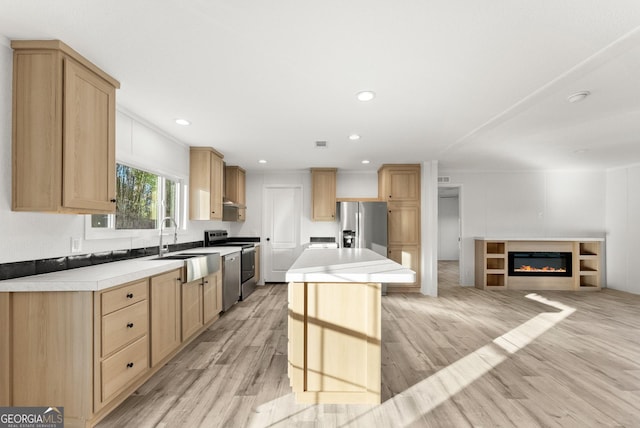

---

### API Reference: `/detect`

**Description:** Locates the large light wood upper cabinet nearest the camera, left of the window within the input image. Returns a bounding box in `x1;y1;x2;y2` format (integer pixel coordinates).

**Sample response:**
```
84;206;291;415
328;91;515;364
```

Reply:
11;40;120;214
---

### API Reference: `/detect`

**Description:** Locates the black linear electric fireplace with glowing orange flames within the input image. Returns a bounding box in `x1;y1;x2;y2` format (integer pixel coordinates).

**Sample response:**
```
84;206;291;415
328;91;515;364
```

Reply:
509;251;572;277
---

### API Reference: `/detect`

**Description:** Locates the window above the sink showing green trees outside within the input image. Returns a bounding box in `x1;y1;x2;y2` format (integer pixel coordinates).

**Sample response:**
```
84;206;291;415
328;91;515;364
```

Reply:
91;164;181;230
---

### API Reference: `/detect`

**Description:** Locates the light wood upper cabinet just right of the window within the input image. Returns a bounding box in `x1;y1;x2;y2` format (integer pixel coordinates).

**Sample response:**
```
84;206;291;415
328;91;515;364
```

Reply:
189;147;224;220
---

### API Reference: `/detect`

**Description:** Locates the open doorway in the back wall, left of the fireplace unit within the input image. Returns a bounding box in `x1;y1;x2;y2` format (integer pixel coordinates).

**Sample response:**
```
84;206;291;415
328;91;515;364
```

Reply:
438;186;462;288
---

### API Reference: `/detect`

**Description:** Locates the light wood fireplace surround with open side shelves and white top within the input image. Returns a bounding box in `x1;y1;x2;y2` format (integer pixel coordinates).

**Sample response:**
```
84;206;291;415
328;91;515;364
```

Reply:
475;237;604;291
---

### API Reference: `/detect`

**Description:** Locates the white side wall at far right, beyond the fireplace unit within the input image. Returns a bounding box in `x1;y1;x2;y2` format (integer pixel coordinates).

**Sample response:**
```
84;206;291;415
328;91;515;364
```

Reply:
606;165;640;294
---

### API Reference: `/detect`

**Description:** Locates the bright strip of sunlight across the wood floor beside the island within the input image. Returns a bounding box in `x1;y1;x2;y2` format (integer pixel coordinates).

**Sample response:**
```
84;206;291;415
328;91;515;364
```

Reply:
249;293;575;427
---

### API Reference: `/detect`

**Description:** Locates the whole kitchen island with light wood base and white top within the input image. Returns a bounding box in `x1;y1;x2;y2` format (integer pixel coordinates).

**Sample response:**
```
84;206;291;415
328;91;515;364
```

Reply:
286;248;415;404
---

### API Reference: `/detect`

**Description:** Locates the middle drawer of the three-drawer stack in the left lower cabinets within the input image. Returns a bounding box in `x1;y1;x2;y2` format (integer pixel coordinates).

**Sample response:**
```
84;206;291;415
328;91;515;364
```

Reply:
102;300;149;357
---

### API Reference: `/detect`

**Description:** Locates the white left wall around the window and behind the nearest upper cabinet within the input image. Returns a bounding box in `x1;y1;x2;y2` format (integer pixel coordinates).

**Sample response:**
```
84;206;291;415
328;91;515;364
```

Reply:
0;42;229;263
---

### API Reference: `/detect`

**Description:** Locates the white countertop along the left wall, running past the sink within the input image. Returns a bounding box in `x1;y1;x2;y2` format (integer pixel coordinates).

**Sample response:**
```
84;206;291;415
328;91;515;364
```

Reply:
0;247;242;292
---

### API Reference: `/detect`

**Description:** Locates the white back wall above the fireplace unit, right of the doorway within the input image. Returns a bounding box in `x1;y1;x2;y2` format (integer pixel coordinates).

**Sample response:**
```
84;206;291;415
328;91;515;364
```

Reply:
440;170;606;285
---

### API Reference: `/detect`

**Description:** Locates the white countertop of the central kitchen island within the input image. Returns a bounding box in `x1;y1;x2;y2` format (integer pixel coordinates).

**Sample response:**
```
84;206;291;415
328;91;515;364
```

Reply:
285;248;416;283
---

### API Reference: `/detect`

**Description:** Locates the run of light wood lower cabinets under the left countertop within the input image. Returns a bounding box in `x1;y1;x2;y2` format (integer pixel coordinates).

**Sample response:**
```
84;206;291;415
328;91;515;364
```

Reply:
0;269;222;428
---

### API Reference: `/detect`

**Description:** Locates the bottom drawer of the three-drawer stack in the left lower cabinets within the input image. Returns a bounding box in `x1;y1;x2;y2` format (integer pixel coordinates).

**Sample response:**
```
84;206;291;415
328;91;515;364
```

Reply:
100;336;149;401
